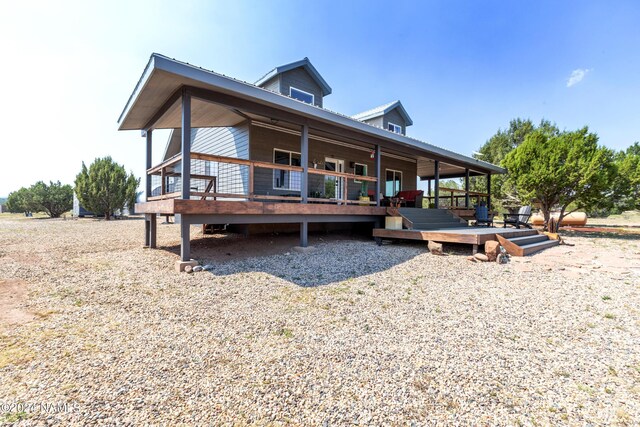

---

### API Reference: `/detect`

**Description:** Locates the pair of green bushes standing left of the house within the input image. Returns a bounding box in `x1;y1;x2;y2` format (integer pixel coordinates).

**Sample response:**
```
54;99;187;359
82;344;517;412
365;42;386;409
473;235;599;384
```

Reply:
7;157;140;219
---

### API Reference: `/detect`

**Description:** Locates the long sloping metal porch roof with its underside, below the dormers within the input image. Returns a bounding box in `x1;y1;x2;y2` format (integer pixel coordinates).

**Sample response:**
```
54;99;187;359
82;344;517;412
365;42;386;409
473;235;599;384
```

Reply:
118;53;506;173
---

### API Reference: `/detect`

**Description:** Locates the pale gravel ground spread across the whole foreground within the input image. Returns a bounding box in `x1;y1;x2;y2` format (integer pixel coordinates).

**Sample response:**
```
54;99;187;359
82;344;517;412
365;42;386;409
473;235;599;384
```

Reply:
0;217;640;426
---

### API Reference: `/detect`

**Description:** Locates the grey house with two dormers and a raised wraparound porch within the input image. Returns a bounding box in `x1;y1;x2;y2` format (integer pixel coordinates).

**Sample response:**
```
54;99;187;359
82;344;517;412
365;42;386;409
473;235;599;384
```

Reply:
119;54;504;268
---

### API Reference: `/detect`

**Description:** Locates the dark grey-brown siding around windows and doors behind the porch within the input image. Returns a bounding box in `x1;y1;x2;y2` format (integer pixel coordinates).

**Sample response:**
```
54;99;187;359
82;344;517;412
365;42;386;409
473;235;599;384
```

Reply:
250;122;417;200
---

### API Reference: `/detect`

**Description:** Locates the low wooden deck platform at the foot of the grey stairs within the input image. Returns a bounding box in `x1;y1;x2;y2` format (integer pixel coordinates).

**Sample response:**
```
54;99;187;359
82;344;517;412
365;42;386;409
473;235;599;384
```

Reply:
373;227;538;246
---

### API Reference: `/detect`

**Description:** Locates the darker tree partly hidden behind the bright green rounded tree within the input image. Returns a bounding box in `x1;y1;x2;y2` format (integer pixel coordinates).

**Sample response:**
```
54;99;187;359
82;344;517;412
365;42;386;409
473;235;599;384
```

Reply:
470;118;559;210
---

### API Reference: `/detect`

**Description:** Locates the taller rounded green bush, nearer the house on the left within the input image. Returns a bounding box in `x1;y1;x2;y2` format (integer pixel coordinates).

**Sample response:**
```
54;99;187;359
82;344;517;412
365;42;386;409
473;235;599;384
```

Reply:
76;157;140;219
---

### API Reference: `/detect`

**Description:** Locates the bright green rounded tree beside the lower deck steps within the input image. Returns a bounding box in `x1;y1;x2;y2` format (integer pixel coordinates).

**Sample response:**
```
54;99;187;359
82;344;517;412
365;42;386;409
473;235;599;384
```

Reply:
502;127;615;224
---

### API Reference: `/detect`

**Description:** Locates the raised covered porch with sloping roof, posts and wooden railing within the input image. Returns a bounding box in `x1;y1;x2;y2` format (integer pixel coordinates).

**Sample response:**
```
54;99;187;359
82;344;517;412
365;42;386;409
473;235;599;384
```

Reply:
119;55;500;261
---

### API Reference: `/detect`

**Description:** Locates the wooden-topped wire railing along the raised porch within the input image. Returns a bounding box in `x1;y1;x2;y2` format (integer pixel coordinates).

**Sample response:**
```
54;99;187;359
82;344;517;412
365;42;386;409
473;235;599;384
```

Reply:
147;152;378;205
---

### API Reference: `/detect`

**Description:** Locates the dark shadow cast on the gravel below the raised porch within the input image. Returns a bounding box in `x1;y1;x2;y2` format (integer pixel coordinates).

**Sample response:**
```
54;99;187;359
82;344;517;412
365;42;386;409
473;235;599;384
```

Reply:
162;234;444;287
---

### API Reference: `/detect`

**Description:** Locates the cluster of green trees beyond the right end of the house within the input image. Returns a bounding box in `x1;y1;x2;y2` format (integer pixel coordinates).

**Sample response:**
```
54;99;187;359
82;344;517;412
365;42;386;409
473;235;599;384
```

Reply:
471;119;640;227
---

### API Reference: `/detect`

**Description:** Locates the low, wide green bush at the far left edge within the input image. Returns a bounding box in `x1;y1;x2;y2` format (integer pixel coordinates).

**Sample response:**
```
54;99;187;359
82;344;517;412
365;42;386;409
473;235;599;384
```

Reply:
7;181;73;218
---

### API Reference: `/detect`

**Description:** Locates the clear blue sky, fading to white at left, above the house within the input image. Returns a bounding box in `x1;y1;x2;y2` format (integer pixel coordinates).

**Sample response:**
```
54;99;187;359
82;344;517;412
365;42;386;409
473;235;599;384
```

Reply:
0;0;640;196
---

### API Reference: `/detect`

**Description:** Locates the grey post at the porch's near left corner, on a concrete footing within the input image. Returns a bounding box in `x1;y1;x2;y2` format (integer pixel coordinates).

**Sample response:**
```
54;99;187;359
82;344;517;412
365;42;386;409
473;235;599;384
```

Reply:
180;89;191;261
